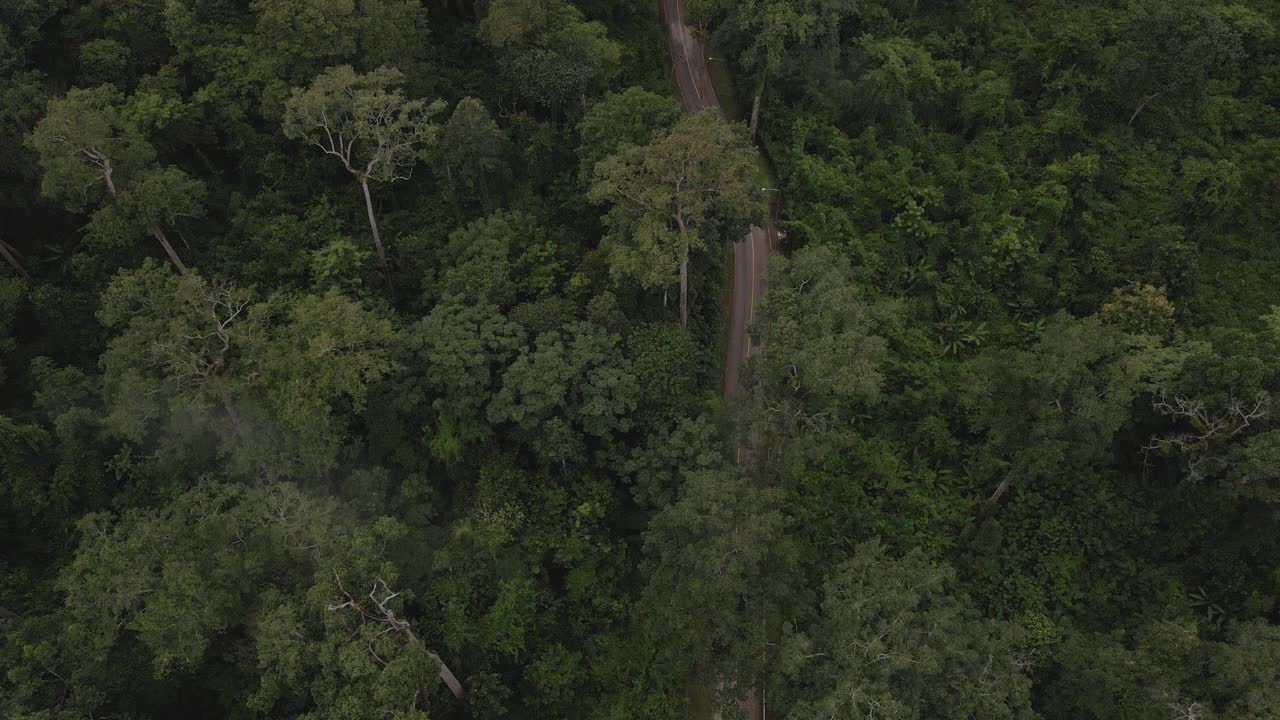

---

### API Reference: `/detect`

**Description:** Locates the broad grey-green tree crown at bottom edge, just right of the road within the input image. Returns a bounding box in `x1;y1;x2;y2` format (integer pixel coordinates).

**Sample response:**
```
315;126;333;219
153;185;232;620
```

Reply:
783;542;1036;720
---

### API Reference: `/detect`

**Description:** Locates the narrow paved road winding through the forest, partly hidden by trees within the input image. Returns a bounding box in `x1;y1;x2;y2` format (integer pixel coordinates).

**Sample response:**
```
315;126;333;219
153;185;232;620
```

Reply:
658;0;772;720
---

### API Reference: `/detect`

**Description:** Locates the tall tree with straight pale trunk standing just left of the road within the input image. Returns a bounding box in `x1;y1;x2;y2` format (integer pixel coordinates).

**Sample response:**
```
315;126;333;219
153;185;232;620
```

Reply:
590;113;765;325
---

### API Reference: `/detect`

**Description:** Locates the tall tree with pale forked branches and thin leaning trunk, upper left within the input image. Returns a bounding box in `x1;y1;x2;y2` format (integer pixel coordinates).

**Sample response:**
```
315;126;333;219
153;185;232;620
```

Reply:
284;65;444;282
